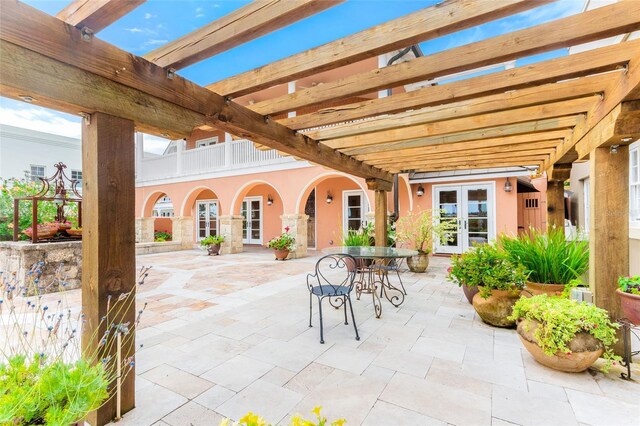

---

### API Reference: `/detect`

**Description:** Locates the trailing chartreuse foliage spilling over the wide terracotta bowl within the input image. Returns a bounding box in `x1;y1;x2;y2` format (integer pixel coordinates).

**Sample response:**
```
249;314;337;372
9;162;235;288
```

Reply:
509;294;620;369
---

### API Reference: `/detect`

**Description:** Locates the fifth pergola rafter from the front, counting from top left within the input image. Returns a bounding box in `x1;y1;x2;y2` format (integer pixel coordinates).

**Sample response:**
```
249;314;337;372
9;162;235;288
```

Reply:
278;40;640;129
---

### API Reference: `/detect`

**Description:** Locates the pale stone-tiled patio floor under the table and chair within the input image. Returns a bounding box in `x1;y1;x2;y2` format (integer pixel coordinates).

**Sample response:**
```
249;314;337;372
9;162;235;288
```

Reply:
119;250;640;426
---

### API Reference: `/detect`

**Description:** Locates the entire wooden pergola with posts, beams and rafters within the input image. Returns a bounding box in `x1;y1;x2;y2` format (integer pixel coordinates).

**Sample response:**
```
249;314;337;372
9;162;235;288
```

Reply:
0;0;640;424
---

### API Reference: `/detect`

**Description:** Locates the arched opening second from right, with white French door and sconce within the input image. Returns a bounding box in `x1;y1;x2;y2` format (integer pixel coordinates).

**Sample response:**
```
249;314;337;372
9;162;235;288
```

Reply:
232;181;284;245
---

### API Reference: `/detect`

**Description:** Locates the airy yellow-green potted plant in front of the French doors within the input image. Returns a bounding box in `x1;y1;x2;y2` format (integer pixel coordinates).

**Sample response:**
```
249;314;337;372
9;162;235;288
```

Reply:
396;209;458;273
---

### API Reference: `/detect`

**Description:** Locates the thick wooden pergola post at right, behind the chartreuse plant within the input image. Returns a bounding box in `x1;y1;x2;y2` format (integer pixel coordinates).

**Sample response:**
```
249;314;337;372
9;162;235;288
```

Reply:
589;146;629;354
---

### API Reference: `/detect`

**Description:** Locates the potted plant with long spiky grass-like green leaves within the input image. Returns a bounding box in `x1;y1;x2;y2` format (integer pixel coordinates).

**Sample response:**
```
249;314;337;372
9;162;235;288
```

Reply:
499;228;589;296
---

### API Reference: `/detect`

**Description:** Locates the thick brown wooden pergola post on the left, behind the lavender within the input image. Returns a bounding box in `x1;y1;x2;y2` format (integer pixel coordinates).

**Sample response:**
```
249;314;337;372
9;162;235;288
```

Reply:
82;112;136;426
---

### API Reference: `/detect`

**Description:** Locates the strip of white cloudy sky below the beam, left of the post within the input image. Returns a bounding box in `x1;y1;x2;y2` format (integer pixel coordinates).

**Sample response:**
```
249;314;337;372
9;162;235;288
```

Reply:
0;98;81;139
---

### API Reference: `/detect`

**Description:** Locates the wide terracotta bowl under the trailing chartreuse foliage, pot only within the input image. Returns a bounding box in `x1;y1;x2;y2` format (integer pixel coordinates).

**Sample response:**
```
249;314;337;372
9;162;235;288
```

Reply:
518;319;604;373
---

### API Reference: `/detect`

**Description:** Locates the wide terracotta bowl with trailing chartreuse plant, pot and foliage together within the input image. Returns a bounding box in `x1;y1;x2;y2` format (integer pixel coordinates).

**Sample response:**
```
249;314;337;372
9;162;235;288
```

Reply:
511;294;619;372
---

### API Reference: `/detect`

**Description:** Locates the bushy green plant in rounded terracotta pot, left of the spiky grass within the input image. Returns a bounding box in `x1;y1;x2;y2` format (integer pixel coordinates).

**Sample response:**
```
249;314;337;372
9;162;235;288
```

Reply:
461;244;527;327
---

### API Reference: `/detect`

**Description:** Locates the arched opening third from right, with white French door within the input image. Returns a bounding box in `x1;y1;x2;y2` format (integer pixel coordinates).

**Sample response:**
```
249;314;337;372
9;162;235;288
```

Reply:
181;186;221;241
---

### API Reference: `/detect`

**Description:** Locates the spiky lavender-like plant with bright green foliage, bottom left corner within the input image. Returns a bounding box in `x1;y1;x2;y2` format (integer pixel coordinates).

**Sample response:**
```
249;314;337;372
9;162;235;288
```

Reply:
0;262;148;426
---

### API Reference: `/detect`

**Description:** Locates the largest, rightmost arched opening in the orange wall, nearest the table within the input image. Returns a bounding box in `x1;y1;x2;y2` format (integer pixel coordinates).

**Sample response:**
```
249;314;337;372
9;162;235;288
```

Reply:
296;173;371;250
